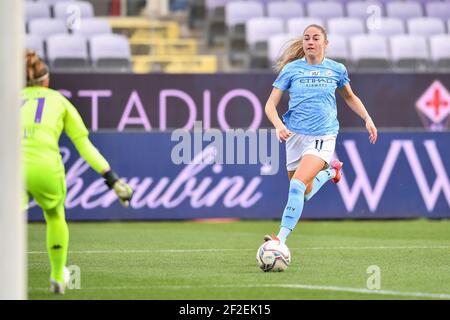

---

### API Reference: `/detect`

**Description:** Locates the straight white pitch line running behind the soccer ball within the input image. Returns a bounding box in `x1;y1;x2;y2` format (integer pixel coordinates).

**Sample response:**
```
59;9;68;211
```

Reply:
28;246;450;254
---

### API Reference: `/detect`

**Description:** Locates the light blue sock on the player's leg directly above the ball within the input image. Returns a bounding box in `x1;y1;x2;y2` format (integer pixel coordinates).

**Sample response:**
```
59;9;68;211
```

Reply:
278;179;306;243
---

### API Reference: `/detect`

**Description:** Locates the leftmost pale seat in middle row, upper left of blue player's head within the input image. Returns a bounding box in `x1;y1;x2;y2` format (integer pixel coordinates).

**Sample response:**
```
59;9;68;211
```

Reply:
245;17;284;47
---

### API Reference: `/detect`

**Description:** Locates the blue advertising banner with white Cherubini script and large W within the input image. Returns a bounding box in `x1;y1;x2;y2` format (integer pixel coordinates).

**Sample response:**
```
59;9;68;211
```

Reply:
29;132;450;221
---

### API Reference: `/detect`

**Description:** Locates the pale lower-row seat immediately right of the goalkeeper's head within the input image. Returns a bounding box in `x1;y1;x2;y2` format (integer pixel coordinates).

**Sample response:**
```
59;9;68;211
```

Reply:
47;34;90;72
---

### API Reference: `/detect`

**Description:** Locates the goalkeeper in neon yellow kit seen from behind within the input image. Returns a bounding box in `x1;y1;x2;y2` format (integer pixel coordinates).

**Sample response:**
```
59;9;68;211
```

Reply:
21;51;133;294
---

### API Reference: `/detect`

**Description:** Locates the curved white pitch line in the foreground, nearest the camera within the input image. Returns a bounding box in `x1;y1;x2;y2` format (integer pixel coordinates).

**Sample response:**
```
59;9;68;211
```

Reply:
29;284;450;299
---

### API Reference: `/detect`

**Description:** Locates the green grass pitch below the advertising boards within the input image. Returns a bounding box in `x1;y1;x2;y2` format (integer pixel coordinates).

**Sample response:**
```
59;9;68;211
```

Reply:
27;220;450;300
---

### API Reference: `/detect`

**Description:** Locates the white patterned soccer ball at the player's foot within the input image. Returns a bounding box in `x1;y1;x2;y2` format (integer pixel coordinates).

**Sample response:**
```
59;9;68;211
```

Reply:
256;240;291;272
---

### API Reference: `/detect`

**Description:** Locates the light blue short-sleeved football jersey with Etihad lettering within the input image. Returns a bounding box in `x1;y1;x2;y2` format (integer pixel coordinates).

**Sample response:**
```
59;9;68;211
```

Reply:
273;58;350;136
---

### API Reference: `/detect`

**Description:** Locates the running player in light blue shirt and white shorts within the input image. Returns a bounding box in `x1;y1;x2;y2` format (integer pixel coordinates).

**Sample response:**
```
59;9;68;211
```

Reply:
264;25;377;243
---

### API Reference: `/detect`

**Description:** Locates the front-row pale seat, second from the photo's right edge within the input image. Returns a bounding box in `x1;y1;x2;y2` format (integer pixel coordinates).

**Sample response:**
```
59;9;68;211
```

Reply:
389;35;429;71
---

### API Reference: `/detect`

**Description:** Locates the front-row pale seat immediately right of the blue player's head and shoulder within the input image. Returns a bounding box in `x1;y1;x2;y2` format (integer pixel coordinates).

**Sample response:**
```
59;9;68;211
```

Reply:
350;34;390;70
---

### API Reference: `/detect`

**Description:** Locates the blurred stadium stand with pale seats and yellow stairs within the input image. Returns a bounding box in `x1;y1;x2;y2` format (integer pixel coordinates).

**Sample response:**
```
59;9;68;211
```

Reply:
26;0;450;73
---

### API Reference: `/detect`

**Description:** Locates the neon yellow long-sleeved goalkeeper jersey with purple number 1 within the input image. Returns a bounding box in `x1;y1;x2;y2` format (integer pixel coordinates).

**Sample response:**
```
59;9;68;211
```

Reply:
21;86;109;173
